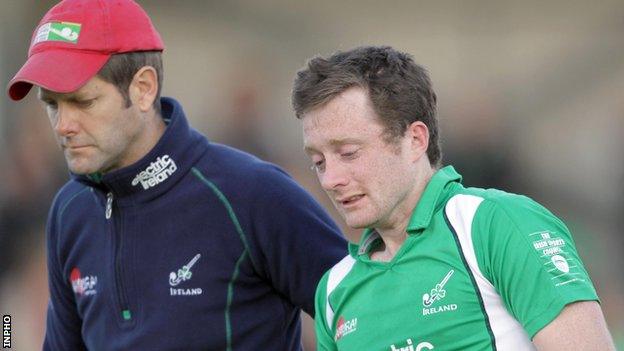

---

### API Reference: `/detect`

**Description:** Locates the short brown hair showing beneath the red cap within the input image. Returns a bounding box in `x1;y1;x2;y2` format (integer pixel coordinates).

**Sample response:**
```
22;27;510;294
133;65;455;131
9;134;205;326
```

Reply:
97;51;163;114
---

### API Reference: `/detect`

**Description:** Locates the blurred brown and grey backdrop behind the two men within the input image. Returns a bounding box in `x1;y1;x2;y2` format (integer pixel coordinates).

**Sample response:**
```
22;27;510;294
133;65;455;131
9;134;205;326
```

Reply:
0;0;624;350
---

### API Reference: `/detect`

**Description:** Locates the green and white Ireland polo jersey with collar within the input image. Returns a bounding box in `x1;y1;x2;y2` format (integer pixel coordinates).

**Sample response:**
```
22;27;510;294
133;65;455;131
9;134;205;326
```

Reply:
315;167;598;351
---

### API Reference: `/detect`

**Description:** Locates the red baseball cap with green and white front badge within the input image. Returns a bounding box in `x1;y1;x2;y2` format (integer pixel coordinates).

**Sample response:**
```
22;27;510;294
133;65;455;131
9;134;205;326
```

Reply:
7;0;164;100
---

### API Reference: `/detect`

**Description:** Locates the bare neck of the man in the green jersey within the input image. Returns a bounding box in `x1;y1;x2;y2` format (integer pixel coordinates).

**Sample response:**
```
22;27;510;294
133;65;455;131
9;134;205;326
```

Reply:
371;166;435;261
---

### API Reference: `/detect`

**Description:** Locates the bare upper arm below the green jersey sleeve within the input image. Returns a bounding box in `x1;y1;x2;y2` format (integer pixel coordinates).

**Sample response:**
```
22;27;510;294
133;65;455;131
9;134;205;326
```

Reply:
533;301;615;351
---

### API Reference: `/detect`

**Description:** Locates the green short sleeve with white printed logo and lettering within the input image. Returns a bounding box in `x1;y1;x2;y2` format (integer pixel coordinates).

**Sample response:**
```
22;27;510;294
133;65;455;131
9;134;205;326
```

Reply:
473;194;598;338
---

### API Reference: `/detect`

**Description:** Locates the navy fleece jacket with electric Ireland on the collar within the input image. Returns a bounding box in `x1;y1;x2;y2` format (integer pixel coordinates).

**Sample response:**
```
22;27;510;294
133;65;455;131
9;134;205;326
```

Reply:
44;98;346;351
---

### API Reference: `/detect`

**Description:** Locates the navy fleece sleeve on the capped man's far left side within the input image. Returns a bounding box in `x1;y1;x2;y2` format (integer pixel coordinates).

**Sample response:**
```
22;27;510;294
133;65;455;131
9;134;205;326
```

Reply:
43;194;87;351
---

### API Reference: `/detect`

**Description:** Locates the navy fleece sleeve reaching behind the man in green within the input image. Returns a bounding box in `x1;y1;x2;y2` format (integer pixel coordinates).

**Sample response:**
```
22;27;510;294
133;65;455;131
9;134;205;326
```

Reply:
250;167;347;317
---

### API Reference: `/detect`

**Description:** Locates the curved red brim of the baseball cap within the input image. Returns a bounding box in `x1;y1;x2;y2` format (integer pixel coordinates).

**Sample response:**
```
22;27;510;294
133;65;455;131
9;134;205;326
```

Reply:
7;50;111;100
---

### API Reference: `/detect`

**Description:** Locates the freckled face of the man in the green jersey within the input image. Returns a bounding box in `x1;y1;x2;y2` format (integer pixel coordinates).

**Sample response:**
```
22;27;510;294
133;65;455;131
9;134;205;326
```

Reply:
302;87;414;228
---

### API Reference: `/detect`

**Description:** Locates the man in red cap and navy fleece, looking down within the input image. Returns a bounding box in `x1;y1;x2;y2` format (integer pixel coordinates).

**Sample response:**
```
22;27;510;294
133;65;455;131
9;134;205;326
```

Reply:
8;0;346;350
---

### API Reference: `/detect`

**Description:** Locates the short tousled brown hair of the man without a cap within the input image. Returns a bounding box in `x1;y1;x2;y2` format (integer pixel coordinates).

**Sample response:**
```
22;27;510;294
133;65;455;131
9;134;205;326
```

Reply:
292;46;442;167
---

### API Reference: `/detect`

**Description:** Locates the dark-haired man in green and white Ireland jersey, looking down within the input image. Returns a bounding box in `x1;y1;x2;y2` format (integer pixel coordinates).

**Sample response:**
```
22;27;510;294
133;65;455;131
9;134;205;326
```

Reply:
293;47;614;351
